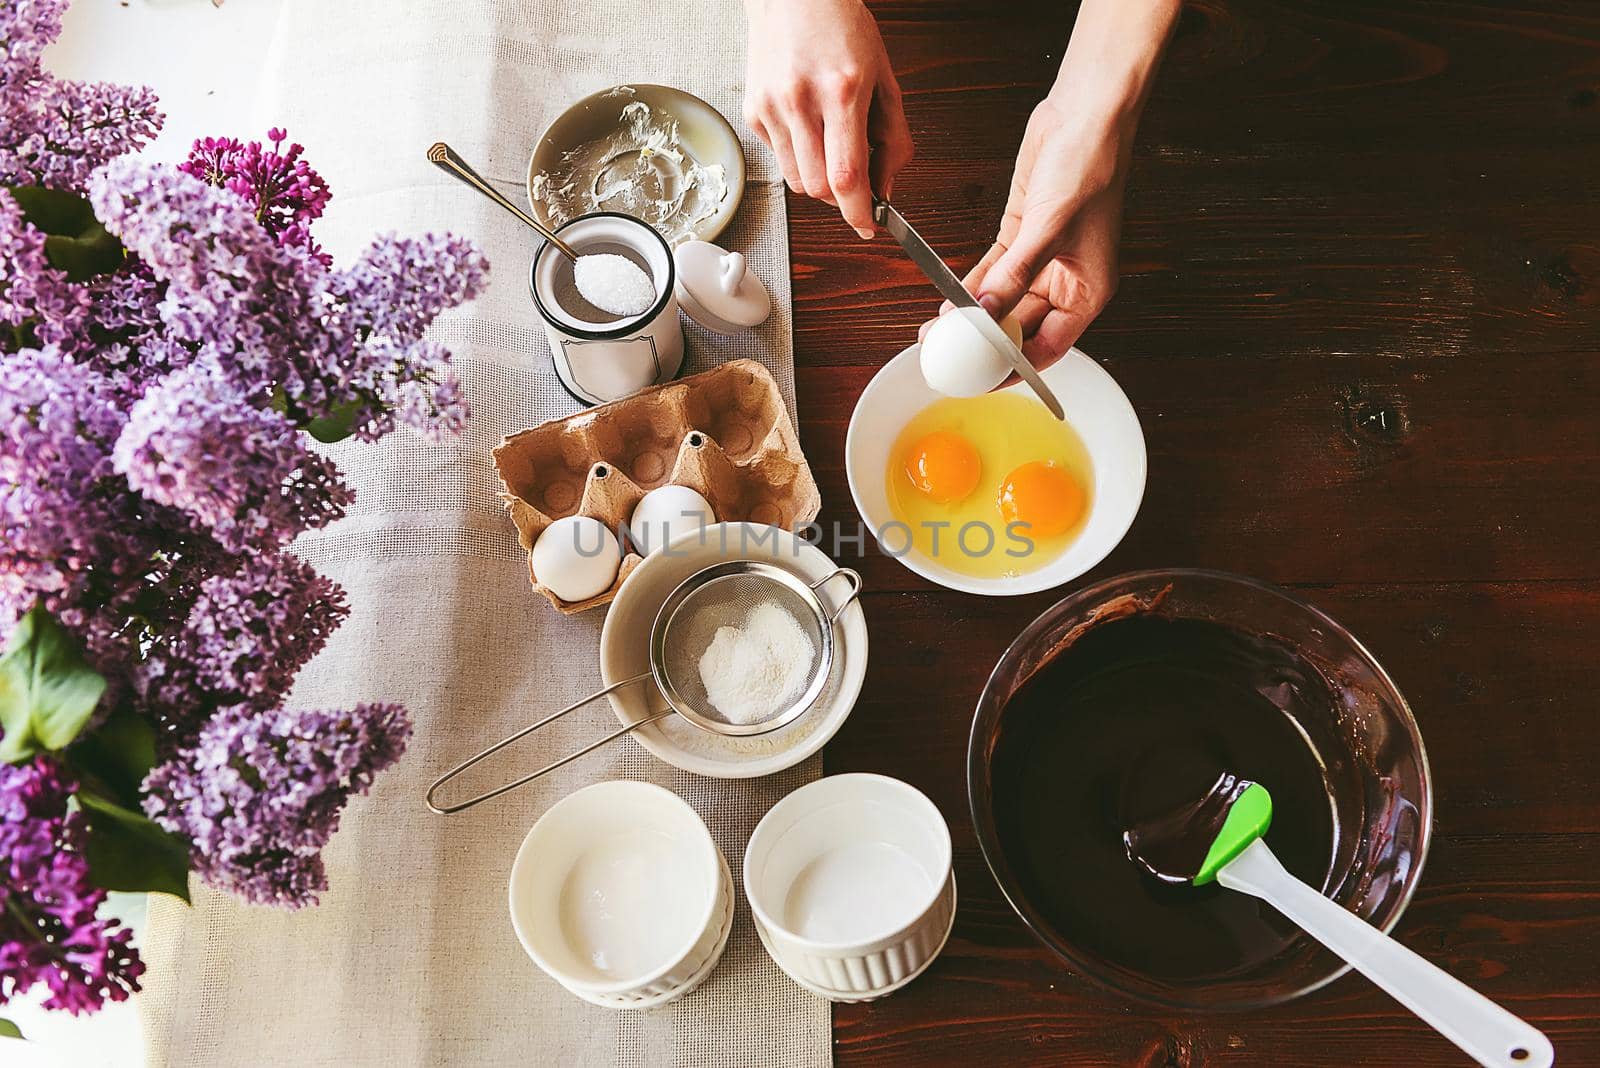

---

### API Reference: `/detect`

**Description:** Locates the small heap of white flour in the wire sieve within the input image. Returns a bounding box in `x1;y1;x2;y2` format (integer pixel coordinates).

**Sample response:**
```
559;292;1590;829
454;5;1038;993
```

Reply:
699;603;816;726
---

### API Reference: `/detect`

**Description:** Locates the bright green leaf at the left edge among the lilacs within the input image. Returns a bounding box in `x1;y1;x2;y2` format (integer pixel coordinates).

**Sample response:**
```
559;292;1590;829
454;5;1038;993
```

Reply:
0;604;106;764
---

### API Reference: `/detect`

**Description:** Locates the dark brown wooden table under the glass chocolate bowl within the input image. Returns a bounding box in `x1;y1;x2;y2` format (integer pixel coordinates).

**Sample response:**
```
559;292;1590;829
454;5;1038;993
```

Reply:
790;0;1600;1068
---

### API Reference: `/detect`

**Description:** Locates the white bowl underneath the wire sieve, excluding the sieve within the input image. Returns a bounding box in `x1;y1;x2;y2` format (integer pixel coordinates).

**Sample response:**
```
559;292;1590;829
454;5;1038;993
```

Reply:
600;523;867;779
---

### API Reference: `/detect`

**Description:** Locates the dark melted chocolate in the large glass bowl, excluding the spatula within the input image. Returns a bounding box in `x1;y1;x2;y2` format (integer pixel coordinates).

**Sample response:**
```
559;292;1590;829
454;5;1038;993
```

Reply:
992;614;1336;985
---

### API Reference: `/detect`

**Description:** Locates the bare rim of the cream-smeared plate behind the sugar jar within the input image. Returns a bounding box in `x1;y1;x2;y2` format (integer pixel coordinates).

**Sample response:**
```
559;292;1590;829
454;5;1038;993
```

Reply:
528;85;744;241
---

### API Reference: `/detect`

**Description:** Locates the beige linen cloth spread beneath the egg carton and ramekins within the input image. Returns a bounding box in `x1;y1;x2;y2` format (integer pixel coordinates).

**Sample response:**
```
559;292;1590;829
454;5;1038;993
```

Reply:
141;0;832;1068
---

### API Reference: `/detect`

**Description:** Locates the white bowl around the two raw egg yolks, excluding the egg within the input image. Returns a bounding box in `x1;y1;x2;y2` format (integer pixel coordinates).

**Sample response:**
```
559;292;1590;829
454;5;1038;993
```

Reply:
845;345;1146;596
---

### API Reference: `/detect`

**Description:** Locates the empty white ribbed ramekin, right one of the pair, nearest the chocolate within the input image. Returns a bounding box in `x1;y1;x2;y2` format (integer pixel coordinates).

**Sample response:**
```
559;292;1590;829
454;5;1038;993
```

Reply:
744;774;955;1001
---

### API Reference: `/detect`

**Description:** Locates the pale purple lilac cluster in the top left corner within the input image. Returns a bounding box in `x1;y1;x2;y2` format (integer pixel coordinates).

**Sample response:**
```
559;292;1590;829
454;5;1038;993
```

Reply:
0;0;162;189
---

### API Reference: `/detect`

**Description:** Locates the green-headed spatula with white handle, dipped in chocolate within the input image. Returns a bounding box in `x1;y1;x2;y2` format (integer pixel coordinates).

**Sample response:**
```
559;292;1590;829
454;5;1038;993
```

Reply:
1125;775;1555;1068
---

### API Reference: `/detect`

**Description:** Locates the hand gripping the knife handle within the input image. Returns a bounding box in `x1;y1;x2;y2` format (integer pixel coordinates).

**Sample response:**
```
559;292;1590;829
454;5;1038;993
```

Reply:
744;0;912;238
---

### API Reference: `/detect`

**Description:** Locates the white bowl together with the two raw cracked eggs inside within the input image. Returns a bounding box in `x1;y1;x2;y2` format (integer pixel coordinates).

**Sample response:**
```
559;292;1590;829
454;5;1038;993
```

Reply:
845;345;1146;596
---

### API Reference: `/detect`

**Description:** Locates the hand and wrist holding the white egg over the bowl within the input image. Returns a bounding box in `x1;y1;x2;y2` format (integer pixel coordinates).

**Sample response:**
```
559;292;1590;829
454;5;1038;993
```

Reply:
920;94;1130;368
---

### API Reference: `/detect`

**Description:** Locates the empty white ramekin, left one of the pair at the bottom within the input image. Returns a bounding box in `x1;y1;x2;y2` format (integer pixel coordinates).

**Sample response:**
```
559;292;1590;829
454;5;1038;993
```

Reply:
510;780;733;1009
